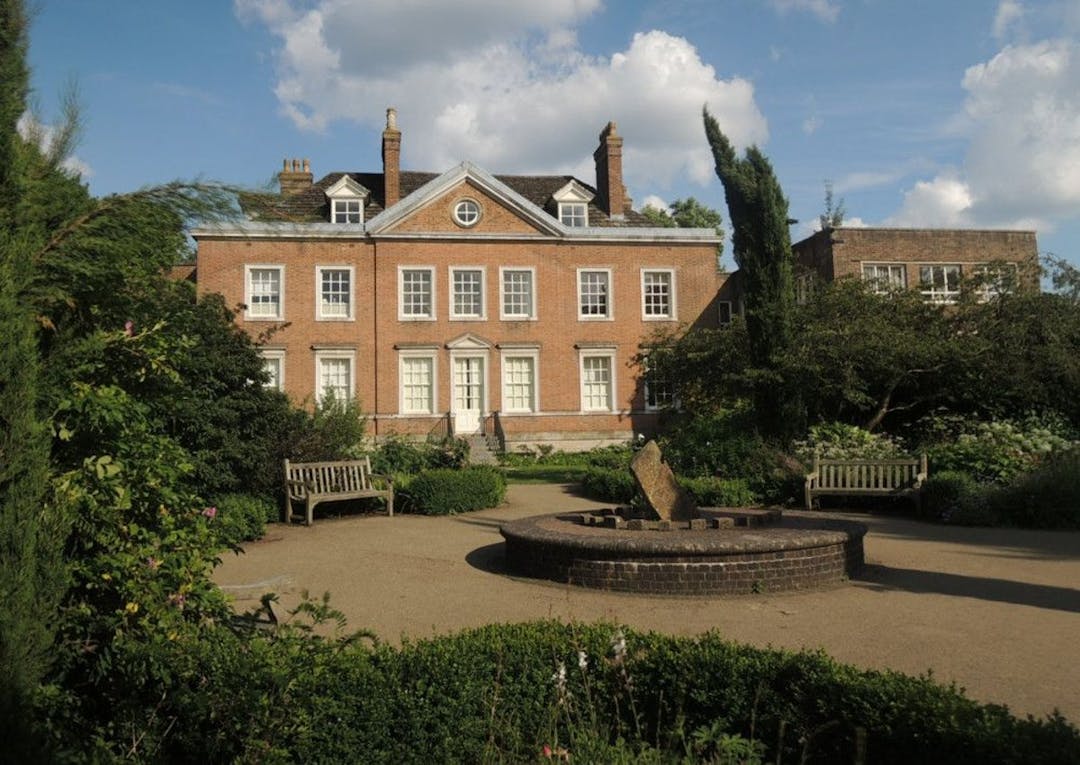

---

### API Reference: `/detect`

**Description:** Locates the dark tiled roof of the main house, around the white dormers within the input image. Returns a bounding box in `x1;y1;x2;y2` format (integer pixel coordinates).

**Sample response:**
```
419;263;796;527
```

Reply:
240;170;651;227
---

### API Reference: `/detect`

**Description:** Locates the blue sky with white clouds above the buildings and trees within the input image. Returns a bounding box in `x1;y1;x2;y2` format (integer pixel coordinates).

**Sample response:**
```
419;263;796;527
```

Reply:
23;0;1080;265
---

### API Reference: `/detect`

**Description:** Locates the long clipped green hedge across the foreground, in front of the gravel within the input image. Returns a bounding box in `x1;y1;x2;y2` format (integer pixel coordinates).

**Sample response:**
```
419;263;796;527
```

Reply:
116;621;1080;765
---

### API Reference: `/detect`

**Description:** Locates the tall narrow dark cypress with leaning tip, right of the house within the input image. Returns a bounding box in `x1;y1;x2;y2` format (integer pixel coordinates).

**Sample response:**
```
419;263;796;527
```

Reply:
703;108;802;440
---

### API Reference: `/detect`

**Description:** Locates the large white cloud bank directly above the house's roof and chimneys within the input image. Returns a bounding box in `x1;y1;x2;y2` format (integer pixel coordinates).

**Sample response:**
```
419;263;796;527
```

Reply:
235;0;768;190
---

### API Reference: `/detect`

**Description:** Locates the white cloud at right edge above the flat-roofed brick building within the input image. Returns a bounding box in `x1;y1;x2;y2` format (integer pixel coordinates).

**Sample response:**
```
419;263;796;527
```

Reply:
895;40;1080;228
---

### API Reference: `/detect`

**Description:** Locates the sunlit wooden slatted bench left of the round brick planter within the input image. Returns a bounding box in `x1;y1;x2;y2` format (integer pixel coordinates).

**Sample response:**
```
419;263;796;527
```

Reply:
285;457;394;526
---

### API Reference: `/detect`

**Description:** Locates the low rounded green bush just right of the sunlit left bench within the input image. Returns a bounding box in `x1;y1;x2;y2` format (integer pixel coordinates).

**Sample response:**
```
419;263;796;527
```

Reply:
401;465;507;515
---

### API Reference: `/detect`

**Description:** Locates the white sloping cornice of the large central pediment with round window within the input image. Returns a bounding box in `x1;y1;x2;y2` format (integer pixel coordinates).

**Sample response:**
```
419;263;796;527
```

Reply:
367;162;566;237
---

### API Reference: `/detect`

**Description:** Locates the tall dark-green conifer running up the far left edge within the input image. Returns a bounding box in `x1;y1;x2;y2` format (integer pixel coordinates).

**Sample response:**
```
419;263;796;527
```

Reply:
0;0;65;762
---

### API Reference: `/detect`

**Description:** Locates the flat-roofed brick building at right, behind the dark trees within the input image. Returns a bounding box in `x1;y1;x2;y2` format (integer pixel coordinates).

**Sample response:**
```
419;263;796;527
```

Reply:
793;227;1039;303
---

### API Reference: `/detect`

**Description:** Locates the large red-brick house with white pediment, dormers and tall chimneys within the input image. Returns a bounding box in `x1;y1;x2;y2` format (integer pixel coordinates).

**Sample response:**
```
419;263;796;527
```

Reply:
192;110;731;448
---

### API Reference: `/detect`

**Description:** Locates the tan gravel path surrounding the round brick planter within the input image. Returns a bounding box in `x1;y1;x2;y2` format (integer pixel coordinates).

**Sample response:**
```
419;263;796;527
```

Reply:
215;484;1080;723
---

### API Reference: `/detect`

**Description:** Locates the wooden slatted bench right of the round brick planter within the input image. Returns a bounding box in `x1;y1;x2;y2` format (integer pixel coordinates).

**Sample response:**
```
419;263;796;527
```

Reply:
806;454;927;510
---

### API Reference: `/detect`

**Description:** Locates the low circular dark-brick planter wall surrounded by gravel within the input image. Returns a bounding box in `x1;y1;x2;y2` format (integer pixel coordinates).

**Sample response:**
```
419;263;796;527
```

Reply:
500;511;866;595
